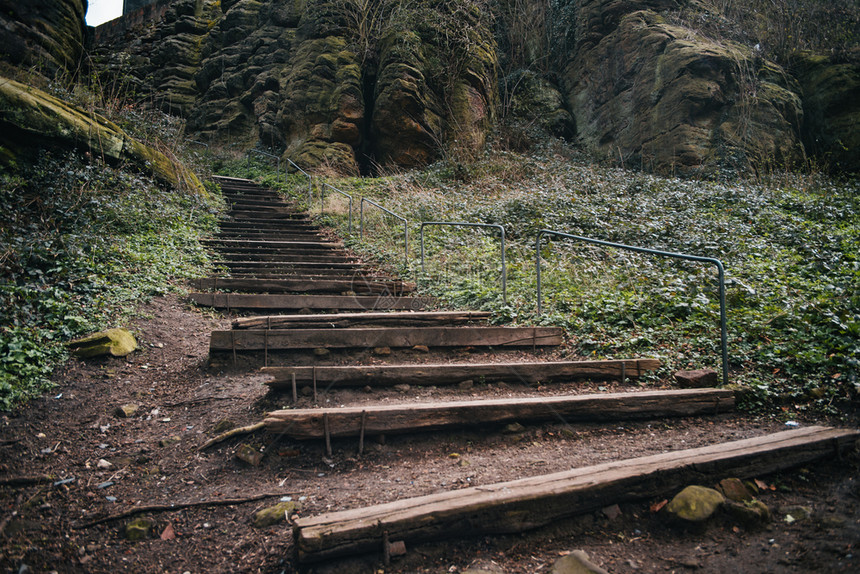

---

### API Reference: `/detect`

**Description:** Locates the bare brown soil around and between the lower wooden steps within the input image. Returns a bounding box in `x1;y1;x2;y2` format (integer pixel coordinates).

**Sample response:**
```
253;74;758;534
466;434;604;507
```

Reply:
0;295;860;573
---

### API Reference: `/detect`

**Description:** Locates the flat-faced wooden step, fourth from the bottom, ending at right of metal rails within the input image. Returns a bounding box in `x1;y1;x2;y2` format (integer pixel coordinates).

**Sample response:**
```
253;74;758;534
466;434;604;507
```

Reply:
209;327;564;352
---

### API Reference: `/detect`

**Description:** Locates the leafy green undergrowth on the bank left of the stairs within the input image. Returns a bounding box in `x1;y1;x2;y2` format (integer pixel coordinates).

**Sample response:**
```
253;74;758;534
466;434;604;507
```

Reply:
0;153;219;410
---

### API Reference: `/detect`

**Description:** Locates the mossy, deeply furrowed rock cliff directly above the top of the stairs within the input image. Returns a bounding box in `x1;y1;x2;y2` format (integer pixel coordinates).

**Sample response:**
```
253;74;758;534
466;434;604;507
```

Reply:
99;0;496;173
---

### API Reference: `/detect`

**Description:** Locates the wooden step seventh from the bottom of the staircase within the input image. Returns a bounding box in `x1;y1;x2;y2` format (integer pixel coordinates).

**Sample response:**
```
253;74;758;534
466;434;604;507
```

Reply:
189;277;415;295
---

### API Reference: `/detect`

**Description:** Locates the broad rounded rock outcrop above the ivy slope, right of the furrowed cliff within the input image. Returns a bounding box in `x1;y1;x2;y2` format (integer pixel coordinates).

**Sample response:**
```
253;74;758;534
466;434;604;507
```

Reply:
562;0;803;173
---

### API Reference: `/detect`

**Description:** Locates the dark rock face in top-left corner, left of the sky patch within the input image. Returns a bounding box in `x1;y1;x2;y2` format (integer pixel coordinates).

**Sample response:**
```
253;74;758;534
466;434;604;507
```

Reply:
0;0;87;77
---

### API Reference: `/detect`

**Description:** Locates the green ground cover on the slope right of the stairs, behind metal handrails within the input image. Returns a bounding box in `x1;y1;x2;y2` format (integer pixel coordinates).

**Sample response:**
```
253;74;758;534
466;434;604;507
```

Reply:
318;153;860;411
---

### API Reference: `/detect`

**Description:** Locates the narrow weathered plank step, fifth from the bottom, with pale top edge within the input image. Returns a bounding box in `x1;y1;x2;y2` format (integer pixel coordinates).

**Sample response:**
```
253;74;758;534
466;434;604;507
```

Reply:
232;311;490;329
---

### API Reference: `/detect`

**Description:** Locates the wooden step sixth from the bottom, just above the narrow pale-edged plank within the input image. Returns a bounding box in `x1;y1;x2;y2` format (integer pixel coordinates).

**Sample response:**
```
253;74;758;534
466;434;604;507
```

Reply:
188;292;434;311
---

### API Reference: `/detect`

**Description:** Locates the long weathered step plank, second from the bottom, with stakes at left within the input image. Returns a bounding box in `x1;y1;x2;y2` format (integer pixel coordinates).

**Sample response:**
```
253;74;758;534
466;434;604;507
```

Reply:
263;389;735;439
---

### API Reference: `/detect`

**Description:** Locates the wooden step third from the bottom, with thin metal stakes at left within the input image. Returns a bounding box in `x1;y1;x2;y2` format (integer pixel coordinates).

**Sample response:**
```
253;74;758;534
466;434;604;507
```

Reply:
262;360;660;390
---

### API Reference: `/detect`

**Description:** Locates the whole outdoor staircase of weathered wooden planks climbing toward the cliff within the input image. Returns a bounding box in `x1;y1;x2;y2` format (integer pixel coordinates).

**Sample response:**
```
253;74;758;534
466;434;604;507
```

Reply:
189;178;860;563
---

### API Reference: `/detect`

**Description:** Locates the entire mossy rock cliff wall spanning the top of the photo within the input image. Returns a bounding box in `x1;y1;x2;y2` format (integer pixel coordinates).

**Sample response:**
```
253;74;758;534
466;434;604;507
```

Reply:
0;0;860;175
